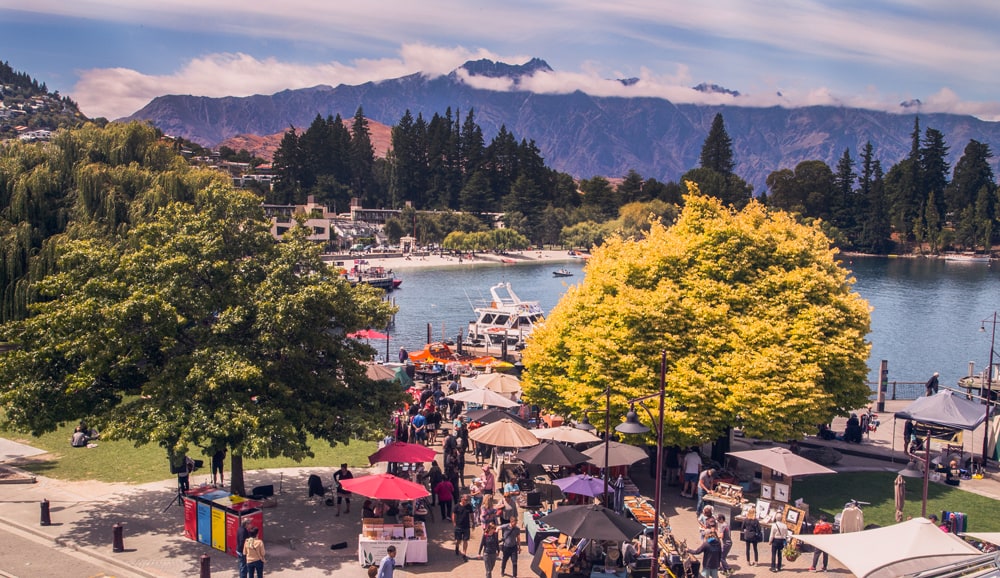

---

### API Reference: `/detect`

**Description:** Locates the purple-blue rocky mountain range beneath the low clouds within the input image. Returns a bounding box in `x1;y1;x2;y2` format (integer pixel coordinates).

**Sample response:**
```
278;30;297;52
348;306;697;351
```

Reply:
122;58;1000;192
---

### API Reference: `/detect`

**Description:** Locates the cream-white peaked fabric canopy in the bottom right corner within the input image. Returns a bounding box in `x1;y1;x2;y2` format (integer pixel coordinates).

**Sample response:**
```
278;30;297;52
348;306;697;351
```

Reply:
795;518;982;578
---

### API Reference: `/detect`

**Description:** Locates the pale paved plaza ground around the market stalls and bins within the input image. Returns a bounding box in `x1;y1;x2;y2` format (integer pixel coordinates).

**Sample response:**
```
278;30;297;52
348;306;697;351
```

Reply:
0;402;1000;578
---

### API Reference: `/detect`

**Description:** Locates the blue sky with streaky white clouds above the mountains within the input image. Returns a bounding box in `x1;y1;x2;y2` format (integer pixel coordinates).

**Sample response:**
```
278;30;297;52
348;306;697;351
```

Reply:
0;0;1000;120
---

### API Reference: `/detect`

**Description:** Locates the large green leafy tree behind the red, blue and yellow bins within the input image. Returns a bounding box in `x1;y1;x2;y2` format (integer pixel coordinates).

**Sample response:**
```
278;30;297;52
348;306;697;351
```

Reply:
0;185;401;493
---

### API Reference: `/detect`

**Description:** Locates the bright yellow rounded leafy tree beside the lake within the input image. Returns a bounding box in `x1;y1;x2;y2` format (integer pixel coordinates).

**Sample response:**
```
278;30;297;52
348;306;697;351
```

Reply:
523;184;870;444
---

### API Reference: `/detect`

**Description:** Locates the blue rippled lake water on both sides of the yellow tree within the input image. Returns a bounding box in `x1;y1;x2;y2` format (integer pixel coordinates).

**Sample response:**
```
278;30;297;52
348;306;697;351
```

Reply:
373;257;1000;397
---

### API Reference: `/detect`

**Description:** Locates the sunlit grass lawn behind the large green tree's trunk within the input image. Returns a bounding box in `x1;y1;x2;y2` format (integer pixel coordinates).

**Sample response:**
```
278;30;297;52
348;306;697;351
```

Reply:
0;424;377;484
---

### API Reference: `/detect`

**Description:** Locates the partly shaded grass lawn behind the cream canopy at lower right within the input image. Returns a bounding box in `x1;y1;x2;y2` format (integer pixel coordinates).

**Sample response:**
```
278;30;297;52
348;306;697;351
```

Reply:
792;472;1000;532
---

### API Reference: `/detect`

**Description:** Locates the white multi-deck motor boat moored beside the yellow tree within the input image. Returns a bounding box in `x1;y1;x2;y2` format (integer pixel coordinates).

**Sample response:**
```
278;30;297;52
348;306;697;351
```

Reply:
468;283;545;345
